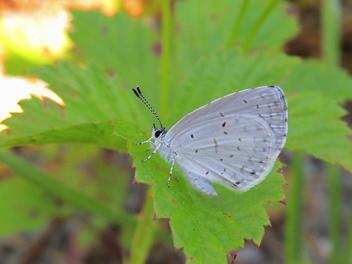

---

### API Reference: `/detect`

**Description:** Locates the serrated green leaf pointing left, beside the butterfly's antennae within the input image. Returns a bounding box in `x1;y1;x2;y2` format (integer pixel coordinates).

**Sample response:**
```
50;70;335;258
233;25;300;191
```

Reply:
0;62;152;151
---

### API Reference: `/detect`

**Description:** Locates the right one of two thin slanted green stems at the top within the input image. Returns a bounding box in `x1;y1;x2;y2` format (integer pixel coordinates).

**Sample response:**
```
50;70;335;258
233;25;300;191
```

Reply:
241;0;280;53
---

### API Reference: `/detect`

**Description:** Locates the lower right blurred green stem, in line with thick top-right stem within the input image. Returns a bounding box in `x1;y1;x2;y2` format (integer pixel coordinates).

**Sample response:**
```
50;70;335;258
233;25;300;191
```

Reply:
328;164;341;263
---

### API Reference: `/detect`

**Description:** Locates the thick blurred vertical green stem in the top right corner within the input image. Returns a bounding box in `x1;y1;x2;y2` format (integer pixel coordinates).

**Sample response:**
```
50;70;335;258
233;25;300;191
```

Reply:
322;0;341;66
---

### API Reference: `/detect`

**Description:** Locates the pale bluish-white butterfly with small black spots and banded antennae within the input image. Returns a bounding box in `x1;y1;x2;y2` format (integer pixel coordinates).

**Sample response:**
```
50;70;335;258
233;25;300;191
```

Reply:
133;86;288;195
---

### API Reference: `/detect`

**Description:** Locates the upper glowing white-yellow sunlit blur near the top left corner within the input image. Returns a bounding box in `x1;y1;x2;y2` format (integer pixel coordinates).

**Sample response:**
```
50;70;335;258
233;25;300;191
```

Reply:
0;10;71;62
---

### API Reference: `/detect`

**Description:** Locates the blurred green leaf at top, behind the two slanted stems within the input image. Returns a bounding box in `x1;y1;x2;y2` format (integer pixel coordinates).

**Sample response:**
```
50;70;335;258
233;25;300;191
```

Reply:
175;0;298;54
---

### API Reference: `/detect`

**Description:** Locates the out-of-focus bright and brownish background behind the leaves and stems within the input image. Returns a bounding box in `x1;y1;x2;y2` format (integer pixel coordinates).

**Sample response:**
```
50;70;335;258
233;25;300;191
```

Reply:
0;0;352;264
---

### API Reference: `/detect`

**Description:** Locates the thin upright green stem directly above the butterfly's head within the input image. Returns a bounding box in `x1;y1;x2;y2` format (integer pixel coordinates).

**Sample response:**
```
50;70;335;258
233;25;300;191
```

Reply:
160;0;171;119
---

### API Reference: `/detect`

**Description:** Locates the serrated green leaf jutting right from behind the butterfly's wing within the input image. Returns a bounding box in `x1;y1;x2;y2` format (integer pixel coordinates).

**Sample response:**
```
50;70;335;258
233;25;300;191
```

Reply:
286;91;352;171
